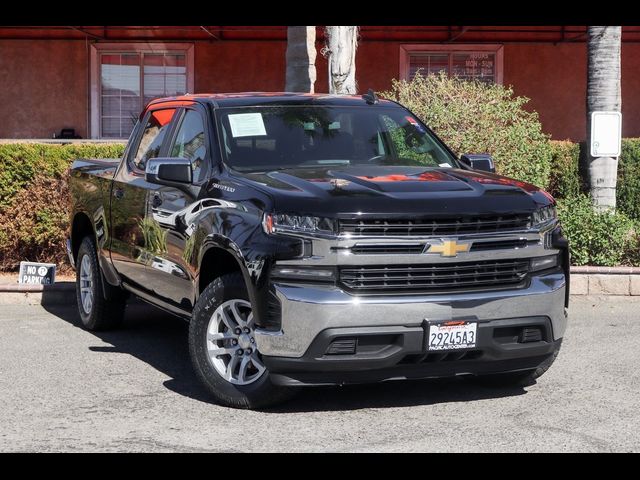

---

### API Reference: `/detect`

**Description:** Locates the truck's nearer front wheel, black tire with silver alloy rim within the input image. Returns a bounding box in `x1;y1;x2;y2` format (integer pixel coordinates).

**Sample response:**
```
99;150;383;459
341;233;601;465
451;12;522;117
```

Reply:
189;273;295;409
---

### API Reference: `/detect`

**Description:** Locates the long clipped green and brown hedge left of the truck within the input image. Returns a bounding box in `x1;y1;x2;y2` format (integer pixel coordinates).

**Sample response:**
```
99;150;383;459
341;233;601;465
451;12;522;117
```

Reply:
0;143;124;270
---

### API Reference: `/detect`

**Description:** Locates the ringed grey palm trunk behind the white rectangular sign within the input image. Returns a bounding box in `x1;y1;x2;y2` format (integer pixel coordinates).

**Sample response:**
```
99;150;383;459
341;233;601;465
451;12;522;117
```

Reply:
585;27;622;211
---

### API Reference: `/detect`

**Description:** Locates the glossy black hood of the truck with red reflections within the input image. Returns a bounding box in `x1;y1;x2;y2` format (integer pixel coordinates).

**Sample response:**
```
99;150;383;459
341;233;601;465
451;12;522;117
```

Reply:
232;166;553;217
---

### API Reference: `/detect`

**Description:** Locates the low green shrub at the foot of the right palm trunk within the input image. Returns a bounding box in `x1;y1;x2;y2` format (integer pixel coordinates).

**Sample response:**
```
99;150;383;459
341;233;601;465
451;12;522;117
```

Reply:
558;194;640;266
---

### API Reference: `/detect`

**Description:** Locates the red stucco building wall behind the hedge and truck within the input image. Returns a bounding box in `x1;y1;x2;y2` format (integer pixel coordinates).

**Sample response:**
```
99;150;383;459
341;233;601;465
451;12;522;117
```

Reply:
0;40;640;140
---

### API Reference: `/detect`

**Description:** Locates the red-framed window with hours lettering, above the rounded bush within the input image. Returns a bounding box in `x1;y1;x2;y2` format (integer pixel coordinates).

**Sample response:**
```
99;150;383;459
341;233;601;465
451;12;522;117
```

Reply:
400;44;502;83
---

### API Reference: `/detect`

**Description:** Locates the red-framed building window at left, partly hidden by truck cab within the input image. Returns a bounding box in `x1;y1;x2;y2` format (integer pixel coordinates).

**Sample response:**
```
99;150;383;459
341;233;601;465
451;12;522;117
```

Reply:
91;44;193;138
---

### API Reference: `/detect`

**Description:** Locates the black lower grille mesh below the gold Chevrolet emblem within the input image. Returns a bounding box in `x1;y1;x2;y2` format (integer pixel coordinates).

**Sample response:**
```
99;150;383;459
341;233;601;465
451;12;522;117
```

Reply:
339;259;529;294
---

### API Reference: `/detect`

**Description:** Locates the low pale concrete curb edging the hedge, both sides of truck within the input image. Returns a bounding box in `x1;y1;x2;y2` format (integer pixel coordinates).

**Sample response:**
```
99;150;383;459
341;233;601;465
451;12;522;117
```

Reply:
0;266;640;305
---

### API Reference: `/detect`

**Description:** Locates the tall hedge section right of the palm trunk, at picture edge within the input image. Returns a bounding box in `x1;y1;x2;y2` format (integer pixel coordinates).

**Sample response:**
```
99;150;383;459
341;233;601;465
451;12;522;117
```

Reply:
616;138;640;221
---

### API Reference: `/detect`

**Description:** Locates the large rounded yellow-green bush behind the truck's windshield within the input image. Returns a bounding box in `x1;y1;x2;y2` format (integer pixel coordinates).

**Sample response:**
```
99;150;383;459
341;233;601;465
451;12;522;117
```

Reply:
381;74;551;188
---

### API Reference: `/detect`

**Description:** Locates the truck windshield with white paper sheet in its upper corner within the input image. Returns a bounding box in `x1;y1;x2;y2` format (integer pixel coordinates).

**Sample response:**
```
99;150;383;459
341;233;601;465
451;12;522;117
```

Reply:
217;105;456;172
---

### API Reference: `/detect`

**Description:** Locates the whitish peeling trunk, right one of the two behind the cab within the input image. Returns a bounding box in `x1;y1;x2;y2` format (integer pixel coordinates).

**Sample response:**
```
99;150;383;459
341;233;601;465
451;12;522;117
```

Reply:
323;26;358;95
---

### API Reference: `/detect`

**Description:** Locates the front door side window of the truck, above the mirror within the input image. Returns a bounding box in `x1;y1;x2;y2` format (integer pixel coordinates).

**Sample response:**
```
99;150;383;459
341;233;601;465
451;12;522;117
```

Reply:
171;110;207;181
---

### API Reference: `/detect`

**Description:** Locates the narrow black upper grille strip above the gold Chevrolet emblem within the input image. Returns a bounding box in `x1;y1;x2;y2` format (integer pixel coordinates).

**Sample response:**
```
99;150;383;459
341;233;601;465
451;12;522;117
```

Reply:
339;214;530;237
